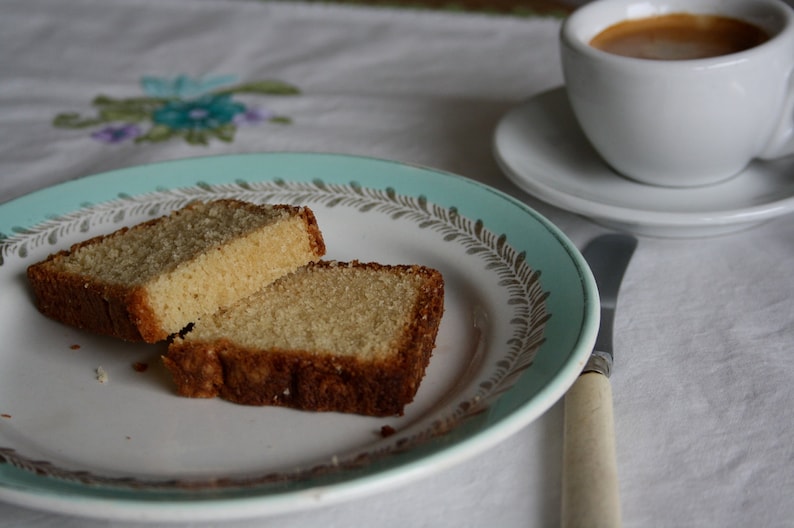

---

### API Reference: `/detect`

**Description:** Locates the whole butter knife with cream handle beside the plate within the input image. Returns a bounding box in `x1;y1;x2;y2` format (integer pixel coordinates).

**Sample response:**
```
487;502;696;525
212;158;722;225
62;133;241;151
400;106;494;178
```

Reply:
562;234;637;528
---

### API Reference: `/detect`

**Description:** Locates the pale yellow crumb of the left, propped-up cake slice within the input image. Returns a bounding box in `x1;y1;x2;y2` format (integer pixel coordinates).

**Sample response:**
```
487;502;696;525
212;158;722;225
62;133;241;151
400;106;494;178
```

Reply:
53;202;318;332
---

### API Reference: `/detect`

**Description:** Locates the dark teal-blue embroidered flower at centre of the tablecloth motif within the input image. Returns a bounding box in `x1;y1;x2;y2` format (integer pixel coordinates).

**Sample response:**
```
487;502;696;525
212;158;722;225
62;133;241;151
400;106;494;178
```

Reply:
152;94;246;130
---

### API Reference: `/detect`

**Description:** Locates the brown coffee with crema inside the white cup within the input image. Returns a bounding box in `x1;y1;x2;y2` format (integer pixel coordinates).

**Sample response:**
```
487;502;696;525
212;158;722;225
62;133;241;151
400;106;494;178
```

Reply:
590;13;769;60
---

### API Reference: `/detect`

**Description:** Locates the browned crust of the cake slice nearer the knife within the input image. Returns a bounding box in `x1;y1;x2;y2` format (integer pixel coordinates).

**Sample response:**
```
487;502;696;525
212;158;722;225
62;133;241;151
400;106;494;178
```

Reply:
163;262;444;416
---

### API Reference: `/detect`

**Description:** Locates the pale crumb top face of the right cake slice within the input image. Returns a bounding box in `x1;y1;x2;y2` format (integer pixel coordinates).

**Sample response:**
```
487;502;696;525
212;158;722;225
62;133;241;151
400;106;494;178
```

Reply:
186;264;422;359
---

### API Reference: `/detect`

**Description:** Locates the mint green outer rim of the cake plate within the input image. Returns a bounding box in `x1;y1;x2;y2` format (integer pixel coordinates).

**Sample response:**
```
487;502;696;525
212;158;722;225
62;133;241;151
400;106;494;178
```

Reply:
0;152;599;521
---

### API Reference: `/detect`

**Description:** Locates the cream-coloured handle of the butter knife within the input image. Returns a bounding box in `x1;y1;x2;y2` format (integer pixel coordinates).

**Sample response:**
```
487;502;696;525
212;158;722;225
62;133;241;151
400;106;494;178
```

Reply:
562;372;621;528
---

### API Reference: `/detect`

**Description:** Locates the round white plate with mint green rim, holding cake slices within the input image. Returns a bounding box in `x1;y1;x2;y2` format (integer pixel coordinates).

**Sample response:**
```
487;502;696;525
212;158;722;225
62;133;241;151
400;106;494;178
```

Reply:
0;153;598;521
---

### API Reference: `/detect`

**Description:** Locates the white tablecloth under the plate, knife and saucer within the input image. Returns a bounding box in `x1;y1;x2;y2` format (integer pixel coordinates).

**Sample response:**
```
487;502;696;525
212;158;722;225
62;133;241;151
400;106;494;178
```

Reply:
0;0;794;528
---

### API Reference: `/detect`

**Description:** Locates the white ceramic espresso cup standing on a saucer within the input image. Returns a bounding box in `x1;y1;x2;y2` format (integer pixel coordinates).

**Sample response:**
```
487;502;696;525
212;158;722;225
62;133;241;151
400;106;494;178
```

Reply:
560;0;794;187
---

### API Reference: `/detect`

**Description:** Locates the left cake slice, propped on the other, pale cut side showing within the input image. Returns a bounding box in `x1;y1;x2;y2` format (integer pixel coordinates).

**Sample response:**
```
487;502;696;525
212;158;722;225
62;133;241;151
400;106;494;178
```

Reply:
28;200;325;343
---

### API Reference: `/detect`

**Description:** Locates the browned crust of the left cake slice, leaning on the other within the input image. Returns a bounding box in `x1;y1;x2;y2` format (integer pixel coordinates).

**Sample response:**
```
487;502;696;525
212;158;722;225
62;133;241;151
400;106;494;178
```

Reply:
27;199;325;343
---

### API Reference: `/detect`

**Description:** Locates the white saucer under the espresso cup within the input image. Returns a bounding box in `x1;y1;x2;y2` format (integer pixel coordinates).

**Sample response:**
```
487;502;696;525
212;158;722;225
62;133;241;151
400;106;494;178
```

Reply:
494;88;794;237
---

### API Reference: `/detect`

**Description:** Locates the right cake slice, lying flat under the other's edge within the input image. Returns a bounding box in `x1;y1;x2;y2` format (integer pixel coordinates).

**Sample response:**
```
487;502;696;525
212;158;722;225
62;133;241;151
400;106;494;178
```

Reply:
163;262;444;416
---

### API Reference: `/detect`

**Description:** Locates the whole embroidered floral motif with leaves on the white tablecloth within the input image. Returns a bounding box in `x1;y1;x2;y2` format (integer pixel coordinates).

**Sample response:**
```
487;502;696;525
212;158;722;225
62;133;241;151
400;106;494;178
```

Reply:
53;75;300;145
